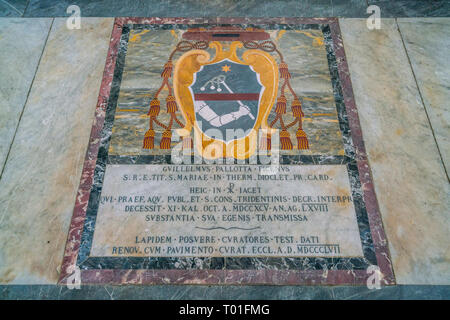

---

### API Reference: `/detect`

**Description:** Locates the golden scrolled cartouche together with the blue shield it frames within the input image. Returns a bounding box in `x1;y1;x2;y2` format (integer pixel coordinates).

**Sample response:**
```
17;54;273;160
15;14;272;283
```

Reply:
174;41;278;159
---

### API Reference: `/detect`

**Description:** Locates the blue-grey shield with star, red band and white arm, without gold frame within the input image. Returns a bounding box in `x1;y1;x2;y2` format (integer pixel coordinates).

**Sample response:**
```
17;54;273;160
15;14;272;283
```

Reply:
189;59;264;142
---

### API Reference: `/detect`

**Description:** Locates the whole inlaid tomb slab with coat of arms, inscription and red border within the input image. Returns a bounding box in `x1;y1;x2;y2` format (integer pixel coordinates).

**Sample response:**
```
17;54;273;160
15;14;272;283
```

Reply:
49;18;395;285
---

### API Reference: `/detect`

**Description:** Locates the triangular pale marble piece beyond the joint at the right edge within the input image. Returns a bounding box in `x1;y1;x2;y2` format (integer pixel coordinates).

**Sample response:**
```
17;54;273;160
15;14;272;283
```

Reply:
397;18;450;176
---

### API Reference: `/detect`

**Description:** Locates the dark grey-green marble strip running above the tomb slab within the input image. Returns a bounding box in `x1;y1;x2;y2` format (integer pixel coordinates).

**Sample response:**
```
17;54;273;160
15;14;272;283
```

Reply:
22;0;450;18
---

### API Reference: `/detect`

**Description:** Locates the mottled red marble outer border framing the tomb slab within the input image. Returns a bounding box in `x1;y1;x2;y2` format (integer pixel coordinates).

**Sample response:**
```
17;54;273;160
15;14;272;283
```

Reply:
59;18;395;285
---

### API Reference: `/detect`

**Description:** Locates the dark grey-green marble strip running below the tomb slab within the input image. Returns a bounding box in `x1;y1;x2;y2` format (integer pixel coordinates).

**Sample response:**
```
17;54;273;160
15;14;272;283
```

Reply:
0;285;450;300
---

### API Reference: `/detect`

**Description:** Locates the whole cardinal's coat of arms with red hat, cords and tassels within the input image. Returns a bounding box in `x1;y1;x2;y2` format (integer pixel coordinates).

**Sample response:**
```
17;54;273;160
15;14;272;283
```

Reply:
143;27;308;159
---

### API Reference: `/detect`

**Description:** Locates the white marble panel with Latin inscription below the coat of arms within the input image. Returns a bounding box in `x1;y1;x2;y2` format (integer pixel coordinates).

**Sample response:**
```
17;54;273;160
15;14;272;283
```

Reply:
90;165;364;258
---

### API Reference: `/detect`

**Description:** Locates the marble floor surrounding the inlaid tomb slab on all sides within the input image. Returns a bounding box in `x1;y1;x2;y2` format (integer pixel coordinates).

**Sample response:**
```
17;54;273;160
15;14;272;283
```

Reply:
0;0;450;299
